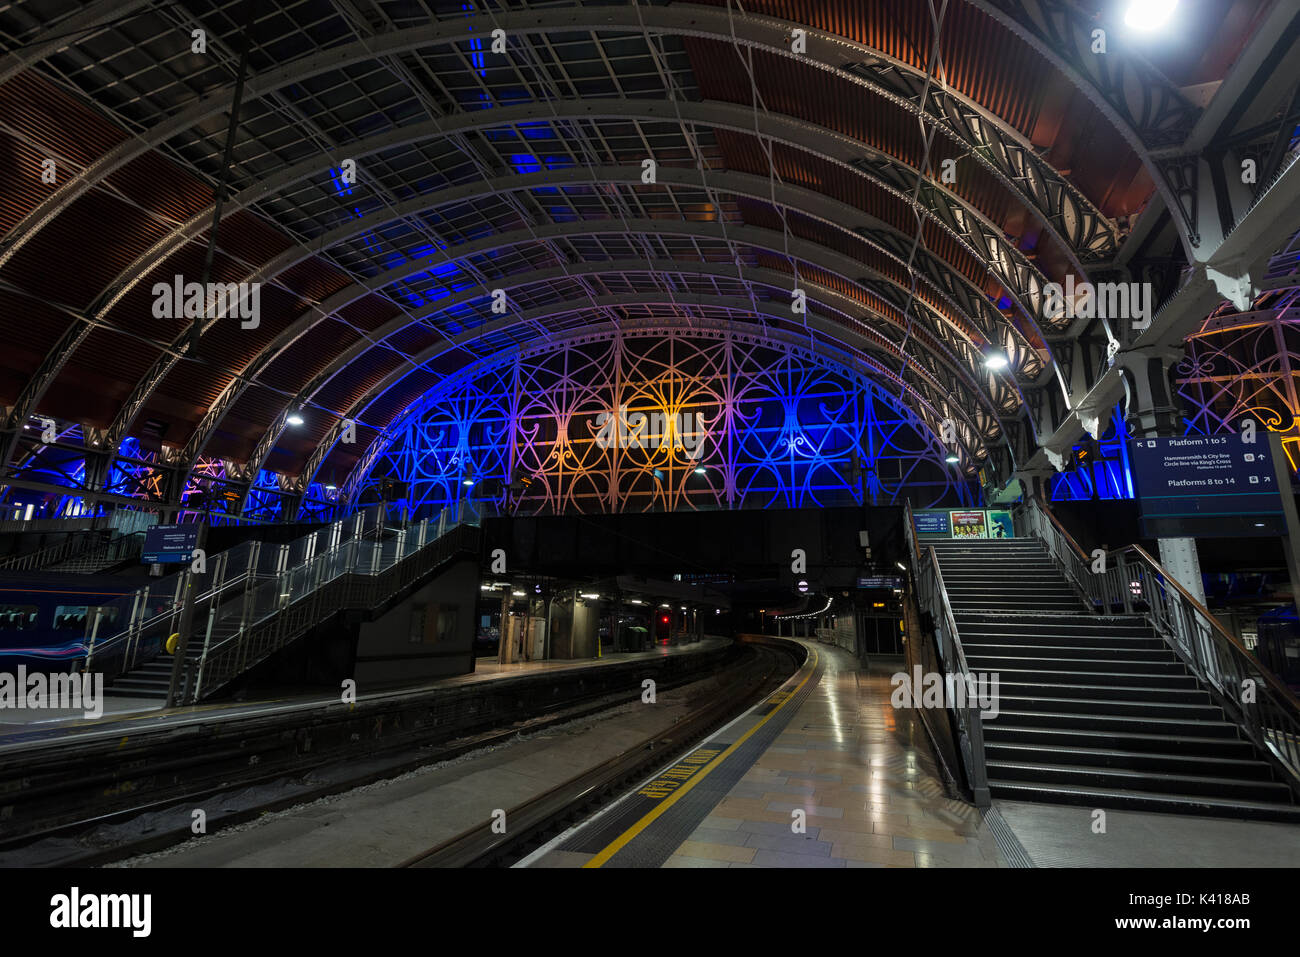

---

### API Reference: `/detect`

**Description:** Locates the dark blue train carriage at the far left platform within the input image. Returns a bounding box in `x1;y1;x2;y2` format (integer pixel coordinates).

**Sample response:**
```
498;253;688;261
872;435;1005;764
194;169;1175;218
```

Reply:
0;571;140;674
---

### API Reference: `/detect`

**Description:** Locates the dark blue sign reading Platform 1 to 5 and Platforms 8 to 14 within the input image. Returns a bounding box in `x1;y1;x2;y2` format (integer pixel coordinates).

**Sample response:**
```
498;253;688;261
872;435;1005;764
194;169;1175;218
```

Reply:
1132;434;1290;538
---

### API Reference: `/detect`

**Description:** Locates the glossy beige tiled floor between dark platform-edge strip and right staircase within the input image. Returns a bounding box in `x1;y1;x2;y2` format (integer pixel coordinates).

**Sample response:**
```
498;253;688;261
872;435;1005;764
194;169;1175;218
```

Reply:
666;645;1008;867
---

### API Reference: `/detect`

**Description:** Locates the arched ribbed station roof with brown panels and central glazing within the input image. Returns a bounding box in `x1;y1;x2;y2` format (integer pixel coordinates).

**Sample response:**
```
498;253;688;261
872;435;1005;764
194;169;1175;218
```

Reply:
0;0;1287;512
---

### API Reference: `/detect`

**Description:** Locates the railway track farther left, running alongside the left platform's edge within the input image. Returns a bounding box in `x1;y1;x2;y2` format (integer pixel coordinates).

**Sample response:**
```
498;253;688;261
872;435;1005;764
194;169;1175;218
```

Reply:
0;634;754;866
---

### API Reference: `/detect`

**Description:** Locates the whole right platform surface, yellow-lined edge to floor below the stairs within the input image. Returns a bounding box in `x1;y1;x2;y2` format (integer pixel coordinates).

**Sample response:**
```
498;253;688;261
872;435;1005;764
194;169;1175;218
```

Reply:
520;642;1300;869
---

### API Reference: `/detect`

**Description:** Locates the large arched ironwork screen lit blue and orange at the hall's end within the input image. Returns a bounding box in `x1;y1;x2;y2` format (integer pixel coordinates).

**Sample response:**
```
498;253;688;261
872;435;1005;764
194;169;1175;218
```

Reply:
347;328;976;515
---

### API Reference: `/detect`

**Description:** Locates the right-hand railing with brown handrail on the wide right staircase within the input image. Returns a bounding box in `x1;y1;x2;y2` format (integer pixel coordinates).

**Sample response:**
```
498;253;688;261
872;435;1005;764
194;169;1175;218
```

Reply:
1024;499;1300;796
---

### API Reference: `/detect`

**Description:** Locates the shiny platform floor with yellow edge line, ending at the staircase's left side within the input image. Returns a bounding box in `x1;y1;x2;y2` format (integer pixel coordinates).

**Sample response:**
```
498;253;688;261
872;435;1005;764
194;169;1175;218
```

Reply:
530;645;1009;867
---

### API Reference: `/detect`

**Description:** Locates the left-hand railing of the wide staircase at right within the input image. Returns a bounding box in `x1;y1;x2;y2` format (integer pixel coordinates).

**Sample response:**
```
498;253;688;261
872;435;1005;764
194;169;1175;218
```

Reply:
904;502;991;807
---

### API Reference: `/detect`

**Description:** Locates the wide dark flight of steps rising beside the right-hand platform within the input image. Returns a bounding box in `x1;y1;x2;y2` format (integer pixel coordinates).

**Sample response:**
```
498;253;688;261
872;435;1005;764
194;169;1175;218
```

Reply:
927;538;1300;822
